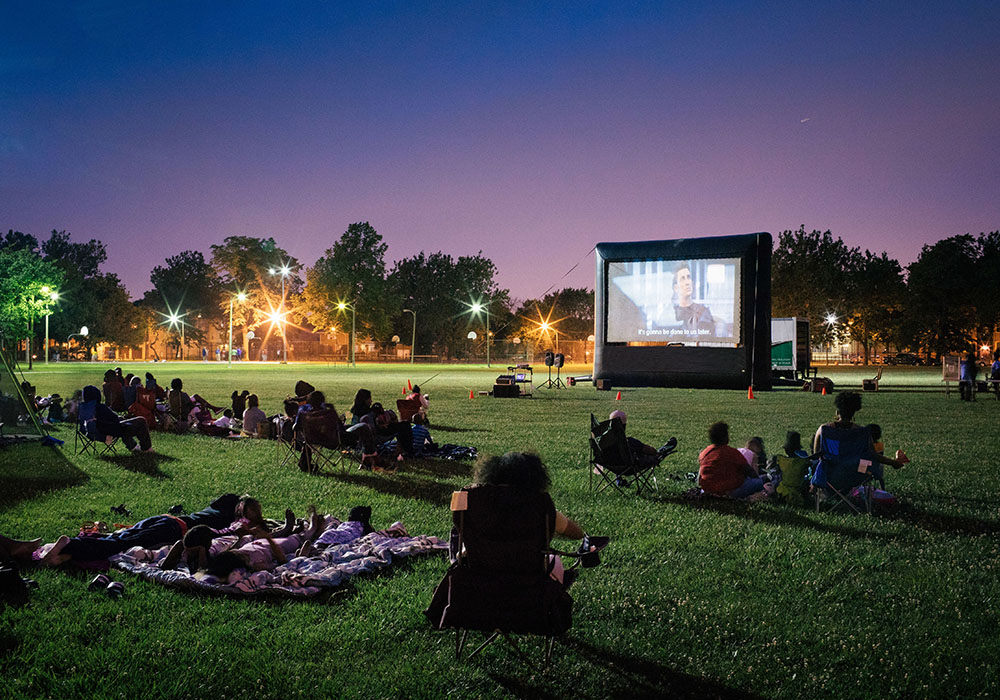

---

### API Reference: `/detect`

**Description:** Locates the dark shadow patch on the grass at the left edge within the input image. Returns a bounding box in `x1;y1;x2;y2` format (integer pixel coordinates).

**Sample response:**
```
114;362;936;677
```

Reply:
0;442;90;510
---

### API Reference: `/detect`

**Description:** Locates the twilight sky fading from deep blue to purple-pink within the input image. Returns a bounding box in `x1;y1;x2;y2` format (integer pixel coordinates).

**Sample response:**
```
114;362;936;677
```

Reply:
0;0;1000;298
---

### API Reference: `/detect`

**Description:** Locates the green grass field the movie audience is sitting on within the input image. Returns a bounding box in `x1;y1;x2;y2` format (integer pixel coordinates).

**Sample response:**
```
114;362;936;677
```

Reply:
0;363;1000;698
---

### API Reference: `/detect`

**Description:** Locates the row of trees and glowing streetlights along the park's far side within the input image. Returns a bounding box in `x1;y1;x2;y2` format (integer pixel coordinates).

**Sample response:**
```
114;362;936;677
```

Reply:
0;222;1000;363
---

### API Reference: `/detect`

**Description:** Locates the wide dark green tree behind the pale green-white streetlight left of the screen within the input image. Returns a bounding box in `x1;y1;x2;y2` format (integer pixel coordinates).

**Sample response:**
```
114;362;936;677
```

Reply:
388;252;509;359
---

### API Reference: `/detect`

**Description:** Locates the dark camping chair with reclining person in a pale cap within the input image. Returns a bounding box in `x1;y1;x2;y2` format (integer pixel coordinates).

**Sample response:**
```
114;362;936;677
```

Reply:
589;413;676;496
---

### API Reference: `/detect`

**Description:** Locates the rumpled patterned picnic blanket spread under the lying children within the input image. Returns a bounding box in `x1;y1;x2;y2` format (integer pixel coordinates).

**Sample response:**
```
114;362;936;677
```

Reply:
110;516;448;598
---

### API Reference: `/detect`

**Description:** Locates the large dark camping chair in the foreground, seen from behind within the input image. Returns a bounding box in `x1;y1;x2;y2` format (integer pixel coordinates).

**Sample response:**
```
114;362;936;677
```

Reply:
424;485;606;664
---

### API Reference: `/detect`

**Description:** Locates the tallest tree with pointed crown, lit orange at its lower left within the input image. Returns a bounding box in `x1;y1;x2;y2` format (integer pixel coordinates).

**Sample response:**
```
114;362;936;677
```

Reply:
301;221;397;341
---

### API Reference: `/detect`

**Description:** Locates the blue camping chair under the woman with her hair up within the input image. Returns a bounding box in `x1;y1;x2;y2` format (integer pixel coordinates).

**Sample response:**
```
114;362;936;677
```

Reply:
812;425;877;514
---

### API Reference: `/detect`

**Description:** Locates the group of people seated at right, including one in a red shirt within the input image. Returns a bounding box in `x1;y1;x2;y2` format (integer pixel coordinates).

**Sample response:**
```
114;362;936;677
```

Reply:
698;391;910;500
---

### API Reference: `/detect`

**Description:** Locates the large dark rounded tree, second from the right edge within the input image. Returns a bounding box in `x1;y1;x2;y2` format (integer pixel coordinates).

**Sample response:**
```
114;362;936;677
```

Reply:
907;234;976;355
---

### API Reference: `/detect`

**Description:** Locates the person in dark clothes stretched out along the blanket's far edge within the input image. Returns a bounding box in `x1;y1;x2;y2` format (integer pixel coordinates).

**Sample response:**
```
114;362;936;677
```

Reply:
32;493;287;566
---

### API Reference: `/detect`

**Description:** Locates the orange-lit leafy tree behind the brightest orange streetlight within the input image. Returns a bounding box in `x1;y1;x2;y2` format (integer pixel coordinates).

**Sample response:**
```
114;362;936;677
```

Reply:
212;236;302;357
